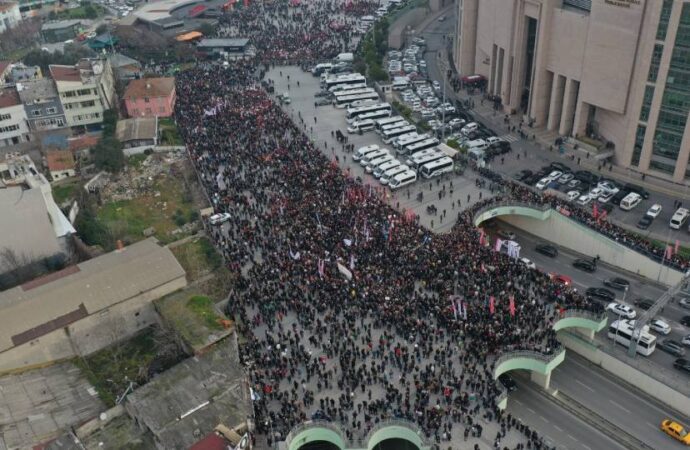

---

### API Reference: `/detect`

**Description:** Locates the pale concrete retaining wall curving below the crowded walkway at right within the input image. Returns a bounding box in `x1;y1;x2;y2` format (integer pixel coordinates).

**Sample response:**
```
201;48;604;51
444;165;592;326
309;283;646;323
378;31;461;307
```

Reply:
497;210;683;285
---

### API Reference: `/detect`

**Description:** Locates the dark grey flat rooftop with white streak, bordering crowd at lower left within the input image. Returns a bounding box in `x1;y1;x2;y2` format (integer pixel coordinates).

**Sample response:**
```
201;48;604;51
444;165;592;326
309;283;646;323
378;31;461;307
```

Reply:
126;335;252;448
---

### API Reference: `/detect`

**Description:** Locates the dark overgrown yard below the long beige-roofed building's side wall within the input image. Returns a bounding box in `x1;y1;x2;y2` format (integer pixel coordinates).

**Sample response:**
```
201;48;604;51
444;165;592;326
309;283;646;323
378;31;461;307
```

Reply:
74;328;184;406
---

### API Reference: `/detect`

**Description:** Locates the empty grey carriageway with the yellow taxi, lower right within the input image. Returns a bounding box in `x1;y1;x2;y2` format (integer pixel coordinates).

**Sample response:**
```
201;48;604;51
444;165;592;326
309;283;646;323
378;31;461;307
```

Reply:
551;352;683;449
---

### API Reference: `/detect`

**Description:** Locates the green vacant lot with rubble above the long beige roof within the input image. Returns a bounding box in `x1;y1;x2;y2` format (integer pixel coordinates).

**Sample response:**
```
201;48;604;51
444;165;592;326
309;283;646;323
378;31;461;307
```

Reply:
97;174;198;243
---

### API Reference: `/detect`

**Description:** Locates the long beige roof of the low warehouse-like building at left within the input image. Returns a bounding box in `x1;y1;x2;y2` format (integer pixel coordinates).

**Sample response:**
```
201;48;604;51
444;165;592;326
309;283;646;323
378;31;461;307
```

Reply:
0;239;185;351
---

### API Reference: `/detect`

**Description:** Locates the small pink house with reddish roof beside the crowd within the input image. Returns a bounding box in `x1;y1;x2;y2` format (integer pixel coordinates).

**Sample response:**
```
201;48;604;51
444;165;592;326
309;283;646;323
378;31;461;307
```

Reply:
124;78;175;117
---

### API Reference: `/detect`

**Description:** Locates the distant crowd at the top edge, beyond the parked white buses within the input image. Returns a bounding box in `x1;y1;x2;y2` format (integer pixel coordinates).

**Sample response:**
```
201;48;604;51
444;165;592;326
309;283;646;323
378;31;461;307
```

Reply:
219;1;378;61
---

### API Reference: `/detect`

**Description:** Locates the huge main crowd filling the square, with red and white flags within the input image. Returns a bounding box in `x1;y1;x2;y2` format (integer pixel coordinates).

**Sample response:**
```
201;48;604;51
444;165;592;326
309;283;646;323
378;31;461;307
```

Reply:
176;62;601;448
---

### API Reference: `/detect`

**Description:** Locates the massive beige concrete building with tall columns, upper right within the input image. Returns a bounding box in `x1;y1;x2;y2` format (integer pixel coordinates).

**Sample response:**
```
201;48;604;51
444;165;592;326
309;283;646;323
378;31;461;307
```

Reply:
454;0;690;182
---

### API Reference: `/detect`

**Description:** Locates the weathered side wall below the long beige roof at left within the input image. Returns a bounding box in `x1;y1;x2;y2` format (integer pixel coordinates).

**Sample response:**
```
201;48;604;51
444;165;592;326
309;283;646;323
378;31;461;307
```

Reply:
0;277;187;373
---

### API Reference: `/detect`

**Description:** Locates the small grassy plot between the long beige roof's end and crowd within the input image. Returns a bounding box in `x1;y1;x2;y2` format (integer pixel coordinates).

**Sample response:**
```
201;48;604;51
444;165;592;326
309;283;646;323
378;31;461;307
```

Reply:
155;286;231;351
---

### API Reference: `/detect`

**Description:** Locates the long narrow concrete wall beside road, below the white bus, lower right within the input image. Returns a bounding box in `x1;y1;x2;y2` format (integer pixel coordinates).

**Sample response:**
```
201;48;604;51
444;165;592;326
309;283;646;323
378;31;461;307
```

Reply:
558;332;690;417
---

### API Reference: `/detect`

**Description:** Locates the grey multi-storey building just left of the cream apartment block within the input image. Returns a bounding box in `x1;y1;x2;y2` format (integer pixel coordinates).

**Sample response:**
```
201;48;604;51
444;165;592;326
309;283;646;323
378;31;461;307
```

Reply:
17;78;67;131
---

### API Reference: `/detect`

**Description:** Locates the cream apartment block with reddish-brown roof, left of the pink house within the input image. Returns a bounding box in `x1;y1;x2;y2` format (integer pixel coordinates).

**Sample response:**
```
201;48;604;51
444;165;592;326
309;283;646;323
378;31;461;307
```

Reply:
50;59;116;128
